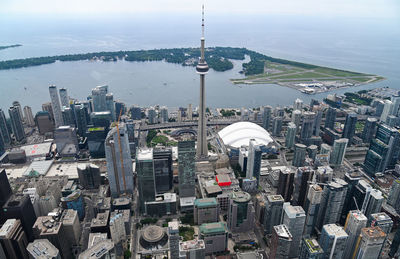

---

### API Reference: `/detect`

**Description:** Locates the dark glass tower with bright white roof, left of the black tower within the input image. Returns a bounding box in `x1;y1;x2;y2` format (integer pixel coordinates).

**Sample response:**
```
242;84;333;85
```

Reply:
136;148;156;213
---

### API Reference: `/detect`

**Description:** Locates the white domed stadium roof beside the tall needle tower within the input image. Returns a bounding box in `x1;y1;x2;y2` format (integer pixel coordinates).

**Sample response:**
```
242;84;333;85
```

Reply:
218;121;273;148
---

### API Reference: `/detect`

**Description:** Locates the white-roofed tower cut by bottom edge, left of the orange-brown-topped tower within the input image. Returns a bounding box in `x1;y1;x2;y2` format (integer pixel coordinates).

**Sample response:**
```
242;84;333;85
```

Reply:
319;224;348;259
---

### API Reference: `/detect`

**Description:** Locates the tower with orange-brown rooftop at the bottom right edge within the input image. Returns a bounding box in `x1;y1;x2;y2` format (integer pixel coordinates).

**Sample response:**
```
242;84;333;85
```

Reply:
354;227;386;259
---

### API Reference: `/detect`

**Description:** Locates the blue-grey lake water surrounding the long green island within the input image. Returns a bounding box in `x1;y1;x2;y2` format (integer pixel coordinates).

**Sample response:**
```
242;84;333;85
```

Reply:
0;15;400;112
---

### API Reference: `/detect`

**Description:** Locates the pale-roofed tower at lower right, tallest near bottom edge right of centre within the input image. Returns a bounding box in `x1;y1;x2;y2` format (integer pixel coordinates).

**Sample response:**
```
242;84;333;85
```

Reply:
282;202;306;257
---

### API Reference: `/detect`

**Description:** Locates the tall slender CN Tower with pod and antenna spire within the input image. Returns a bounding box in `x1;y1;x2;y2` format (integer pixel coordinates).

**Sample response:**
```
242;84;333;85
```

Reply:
196;5;208;159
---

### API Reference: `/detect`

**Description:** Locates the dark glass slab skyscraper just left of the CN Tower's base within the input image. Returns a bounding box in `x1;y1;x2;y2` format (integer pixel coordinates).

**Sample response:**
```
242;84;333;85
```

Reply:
178;140;196;197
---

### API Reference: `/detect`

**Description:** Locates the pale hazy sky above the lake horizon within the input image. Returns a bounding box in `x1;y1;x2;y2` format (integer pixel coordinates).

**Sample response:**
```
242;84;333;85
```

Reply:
0;0;400;19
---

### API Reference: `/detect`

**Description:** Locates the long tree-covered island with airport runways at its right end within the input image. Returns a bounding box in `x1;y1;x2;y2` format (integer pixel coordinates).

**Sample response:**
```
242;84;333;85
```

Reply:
0;47;384;94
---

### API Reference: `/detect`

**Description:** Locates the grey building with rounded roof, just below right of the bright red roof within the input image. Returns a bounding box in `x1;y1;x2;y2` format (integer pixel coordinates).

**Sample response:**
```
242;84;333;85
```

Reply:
228;191;255;233
